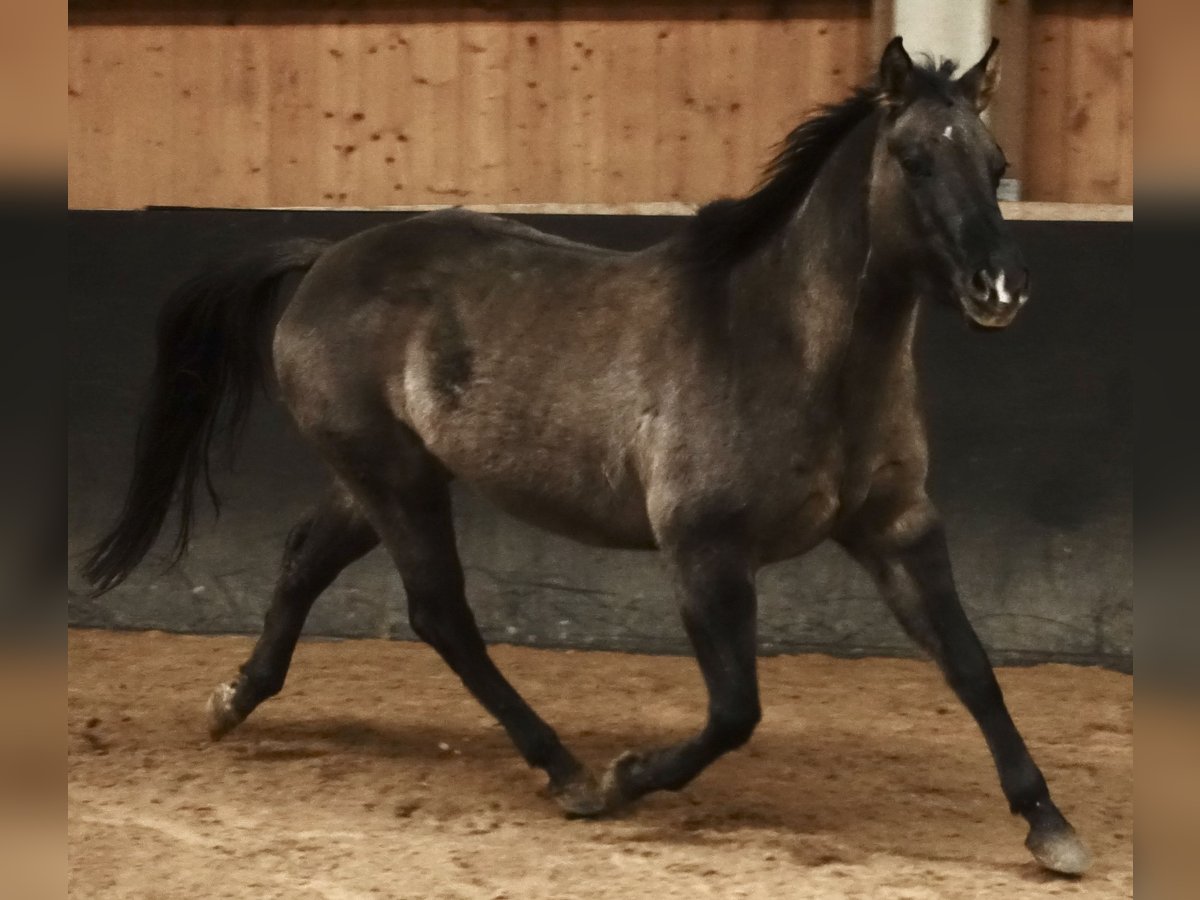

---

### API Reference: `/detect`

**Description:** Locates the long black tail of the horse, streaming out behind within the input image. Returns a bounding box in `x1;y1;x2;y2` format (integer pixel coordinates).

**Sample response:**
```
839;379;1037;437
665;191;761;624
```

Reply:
83;239;328;594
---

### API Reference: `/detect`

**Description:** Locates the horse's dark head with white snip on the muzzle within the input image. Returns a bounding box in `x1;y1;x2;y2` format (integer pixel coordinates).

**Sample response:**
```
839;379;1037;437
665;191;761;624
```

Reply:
871;37;1030;328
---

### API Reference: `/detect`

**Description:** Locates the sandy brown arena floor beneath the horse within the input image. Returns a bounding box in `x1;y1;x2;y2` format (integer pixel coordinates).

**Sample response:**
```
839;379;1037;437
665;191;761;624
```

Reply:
67;631;1133;900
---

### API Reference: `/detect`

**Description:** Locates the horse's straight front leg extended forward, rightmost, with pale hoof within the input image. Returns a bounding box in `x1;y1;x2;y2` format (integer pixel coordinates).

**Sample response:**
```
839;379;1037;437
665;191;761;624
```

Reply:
841;498;1091;875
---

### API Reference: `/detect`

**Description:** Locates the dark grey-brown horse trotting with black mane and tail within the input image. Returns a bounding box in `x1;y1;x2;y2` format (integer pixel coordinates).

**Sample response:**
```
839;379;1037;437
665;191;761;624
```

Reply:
83;37;1090;875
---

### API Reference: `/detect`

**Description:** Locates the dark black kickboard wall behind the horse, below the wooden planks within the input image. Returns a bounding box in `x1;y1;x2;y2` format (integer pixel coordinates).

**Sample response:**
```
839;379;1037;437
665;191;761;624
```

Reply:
67;209;1133;668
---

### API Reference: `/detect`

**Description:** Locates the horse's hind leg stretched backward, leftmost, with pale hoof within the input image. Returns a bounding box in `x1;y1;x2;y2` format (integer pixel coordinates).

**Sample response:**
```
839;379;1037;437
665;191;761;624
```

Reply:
209;487;379;740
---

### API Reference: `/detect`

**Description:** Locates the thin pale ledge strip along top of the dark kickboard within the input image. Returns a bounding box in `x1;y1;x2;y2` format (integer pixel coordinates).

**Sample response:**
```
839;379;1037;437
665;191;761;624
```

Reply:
241;202;1133;222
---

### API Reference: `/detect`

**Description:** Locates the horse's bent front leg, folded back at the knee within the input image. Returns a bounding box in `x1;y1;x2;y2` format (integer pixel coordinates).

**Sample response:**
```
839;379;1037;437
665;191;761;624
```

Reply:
590;540;761;810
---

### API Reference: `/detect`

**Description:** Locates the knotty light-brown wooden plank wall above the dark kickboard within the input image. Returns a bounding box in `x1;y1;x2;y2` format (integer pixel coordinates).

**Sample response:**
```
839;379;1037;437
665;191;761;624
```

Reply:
67;0;1133;208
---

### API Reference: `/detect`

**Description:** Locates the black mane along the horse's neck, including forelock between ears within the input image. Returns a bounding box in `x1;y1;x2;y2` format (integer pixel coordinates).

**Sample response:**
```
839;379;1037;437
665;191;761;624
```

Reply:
686;60;955;274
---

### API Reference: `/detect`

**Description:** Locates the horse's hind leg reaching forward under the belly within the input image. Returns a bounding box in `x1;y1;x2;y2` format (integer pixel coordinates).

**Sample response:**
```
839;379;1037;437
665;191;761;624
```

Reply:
331;453;599;815
